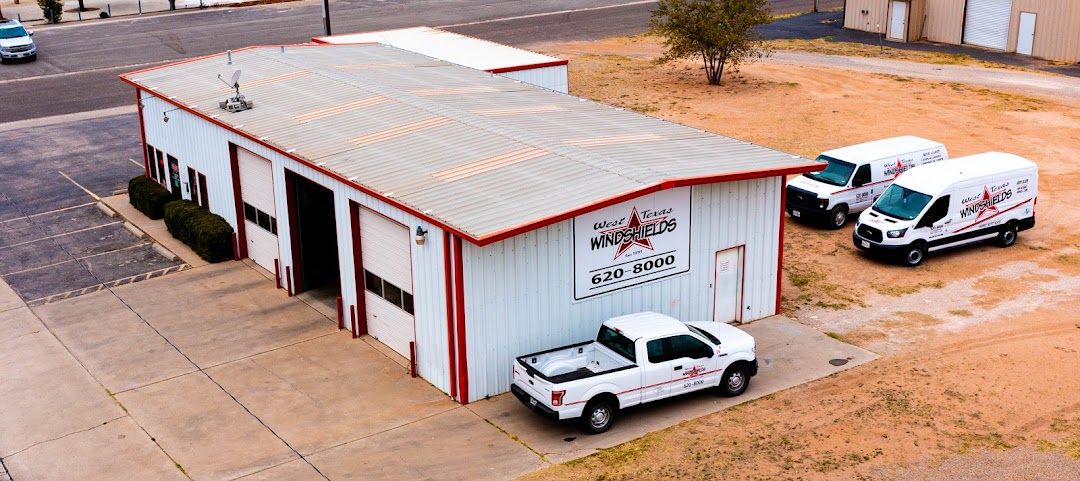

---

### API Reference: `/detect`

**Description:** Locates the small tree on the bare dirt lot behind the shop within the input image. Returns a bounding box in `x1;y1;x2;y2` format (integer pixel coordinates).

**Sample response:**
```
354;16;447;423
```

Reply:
649;0;772;85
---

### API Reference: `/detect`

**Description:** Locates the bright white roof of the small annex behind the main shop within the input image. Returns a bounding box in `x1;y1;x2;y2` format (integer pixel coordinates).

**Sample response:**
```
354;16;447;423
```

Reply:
311;27;566;71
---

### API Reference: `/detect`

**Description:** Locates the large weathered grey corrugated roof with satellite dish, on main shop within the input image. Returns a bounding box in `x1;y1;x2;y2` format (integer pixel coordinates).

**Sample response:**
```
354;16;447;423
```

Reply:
121;44;822;244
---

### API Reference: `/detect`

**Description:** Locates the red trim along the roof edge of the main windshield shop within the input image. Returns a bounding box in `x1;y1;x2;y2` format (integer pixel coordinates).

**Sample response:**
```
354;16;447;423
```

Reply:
120;56;825;246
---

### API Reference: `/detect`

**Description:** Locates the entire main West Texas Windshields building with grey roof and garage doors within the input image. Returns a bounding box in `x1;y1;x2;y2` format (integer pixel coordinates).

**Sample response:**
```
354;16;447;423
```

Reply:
121;44;821;403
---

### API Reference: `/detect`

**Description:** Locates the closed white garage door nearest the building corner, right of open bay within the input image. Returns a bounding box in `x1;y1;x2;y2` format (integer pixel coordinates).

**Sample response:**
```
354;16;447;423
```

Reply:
360;209;415;358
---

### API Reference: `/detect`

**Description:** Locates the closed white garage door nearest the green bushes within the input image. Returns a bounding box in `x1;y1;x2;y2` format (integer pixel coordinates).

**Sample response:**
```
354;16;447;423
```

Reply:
237;147;278;272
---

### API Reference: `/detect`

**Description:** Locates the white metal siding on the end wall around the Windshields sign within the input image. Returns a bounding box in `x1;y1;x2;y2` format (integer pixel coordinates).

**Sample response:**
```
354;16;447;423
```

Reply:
462;177;781;400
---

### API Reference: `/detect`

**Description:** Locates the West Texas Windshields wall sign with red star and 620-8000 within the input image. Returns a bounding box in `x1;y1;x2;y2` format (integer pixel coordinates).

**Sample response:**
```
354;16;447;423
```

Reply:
573;187;690;300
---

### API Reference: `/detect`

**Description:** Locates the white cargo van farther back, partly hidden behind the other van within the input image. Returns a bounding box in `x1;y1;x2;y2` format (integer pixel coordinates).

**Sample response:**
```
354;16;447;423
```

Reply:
784;135;948;229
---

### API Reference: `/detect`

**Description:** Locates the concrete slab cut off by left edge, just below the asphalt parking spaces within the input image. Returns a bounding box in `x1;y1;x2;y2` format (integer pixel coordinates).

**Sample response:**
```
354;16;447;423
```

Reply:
0;308;124;457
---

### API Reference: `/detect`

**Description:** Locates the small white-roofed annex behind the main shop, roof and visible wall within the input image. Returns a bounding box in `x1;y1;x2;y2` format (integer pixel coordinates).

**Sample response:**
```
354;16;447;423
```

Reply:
311;27;569;94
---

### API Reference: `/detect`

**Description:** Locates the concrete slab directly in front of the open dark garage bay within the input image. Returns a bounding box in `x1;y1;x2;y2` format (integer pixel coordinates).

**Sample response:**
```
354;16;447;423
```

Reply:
113;262;337;369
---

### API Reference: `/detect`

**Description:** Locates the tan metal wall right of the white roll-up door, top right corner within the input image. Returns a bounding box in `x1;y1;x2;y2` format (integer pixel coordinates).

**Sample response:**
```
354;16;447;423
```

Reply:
1008;0;1080;62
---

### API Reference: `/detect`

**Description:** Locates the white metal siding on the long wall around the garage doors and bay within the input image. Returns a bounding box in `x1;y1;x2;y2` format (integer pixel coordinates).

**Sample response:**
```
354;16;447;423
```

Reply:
140;92;450;392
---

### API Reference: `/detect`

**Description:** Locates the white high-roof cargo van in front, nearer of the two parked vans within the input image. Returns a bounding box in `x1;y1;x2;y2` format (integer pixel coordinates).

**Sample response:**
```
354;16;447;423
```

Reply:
851;152;1039;267
